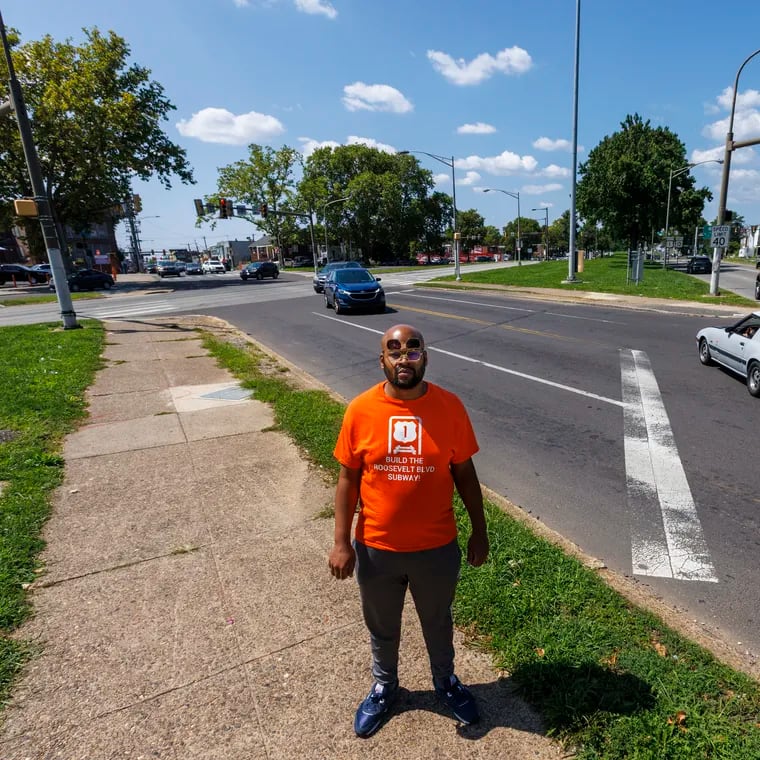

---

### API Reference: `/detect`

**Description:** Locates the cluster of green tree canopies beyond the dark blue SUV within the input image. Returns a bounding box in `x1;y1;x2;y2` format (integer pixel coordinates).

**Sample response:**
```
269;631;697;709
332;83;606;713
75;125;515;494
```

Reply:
209;144;452;261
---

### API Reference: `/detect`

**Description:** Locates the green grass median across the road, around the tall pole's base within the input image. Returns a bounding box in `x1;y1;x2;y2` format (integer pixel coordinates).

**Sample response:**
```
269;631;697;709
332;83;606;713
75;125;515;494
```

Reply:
430;253;756;307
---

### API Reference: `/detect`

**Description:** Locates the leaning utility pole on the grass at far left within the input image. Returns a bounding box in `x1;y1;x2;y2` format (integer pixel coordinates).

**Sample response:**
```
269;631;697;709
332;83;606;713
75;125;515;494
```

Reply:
0;14;80;330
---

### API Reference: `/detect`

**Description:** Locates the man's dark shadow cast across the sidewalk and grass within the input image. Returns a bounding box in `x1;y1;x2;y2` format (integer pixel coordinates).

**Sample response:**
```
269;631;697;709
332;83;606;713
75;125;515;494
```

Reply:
391;662;654;740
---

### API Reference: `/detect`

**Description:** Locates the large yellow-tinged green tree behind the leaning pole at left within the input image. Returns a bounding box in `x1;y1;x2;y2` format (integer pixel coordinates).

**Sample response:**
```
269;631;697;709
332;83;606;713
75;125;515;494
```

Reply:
0;28;194;255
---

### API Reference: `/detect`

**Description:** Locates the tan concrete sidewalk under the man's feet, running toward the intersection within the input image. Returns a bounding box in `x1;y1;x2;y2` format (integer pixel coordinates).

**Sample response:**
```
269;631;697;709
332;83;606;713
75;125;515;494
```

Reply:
0;318;562;760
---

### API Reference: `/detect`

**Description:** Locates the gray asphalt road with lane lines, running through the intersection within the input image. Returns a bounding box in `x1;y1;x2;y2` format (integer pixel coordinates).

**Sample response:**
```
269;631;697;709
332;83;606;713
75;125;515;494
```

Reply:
0;268;760;652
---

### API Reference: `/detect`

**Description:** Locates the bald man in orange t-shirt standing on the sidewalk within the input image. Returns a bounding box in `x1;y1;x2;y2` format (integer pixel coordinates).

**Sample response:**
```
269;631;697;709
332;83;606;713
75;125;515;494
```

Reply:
329;325;488;737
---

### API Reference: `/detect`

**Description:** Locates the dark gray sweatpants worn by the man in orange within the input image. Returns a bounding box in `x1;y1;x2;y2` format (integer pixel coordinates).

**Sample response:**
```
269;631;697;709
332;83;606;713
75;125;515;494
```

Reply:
354;541;462;684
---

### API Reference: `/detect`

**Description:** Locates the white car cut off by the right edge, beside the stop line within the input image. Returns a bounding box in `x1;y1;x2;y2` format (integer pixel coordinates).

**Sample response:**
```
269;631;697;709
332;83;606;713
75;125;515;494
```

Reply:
697;311;760;397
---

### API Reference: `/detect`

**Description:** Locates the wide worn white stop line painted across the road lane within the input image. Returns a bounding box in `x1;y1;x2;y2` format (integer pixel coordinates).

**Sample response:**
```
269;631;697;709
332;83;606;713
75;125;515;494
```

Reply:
620;349;718;583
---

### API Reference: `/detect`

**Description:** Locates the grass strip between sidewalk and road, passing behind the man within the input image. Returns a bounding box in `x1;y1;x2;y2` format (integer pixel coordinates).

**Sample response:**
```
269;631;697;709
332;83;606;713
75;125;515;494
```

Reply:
204;336;760;760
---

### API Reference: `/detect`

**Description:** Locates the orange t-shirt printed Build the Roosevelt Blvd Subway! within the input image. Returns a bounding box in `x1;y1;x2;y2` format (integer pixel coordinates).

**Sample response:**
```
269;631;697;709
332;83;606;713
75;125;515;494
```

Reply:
334;382;478;552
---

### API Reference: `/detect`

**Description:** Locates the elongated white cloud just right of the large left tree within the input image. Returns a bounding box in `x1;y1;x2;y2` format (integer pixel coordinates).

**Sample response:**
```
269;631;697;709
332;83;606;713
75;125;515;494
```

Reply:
177;108;285;145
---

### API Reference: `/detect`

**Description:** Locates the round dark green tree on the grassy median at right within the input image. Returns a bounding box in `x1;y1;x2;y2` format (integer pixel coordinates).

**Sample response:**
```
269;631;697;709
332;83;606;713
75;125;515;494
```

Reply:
577;114;712;247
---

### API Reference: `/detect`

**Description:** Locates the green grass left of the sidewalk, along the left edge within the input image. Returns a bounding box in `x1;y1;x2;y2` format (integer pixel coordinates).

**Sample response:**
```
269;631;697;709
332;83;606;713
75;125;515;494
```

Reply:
0;321;103;702
